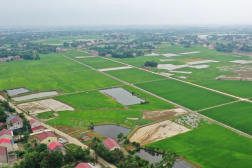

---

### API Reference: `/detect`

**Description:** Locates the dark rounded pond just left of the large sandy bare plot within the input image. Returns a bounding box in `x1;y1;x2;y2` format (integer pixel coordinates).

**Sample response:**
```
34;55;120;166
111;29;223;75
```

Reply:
94;125;130;139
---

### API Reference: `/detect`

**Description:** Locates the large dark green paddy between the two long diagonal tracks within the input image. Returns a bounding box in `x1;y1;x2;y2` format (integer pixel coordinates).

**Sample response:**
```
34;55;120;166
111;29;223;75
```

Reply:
136;79;235;110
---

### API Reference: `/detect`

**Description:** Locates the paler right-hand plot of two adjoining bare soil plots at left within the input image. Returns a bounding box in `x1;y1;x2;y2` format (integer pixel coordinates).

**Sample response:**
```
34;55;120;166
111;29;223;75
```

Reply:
37;99;74;111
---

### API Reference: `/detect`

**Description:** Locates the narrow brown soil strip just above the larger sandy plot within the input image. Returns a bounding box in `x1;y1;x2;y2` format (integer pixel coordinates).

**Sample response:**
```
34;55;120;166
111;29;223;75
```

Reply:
142;108;187;120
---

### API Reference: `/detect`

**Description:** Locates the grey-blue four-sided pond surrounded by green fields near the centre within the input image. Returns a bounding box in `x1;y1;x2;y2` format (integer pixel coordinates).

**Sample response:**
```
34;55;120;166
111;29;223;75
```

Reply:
100;88;144;106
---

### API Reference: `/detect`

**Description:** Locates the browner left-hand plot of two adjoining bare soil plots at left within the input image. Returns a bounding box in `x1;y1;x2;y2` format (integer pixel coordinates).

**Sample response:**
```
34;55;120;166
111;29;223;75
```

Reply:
17;102;51;114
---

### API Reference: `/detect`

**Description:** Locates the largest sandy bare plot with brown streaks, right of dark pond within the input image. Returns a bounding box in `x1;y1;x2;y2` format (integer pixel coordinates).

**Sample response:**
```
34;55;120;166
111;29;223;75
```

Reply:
130;120;190;145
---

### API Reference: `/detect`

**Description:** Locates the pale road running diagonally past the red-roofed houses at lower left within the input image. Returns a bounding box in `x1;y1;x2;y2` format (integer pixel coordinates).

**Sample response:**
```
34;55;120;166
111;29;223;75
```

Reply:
0;95;116;168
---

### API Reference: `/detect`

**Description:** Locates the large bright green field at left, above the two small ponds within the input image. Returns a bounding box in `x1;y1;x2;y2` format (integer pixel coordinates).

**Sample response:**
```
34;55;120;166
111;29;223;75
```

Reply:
0;54;121;92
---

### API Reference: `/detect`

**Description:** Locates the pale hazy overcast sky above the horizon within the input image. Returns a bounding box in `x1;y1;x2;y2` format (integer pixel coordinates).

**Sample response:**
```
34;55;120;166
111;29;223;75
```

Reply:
0;0;252;27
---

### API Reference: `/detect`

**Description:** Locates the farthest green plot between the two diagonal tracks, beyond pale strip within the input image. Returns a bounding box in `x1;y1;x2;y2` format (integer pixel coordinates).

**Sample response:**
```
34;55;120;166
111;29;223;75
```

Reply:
76;57;125;69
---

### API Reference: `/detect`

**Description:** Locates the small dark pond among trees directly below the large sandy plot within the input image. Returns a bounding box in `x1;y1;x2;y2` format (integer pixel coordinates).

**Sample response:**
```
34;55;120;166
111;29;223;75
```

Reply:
135;149;163;164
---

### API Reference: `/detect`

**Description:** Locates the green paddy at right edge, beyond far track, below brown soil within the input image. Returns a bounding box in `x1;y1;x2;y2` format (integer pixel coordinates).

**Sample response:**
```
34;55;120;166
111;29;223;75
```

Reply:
195;80;252;98
